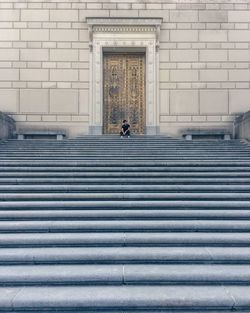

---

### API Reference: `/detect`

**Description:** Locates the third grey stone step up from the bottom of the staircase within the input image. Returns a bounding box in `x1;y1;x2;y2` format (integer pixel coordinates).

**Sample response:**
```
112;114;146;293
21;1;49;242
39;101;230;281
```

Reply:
0;246;250;265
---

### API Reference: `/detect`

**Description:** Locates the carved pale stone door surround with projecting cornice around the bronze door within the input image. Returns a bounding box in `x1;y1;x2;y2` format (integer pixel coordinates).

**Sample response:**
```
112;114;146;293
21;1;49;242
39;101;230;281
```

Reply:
87;18;162;135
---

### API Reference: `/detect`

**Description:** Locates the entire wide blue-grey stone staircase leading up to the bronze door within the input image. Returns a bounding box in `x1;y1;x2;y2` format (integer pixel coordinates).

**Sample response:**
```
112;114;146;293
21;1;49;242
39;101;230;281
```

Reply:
0;136;250;313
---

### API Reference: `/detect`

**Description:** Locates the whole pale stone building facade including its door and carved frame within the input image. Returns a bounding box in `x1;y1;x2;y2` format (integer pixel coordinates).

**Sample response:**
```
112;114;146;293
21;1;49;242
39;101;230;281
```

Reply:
0;0;250;137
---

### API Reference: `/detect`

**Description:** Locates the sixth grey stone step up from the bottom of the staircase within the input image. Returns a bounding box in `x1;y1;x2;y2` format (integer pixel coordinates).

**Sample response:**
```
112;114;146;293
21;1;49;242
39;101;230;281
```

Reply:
0;208;250;221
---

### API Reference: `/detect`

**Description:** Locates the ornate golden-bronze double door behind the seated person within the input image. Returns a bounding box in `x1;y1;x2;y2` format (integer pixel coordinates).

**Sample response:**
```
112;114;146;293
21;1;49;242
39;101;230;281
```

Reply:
103;54;145;134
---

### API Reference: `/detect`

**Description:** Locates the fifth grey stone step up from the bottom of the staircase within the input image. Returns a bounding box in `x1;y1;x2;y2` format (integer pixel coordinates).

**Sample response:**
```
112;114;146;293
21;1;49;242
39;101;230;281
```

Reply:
0;217;250;233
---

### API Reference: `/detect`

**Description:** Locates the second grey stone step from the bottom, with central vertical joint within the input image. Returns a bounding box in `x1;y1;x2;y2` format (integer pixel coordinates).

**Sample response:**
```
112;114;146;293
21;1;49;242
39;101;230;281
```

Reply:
0;264;250;286
